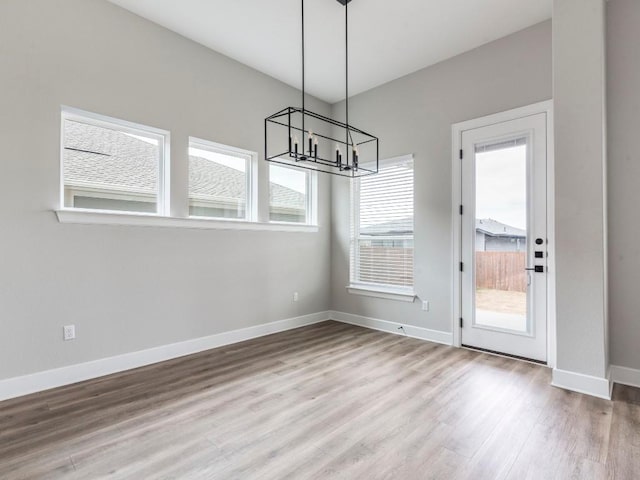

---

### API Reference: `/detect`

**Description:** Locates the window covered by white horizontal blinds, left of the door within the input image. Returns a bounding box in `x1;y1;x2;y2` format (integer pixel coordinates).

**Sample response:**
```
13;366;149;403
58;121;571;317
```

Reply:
351;156;413;291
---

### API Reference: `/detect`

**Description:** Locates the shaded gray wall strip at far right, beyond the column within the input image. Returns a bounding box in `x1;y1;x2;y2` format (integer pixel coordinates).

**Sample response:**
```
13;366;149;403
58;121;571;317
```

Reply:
607;0;640;369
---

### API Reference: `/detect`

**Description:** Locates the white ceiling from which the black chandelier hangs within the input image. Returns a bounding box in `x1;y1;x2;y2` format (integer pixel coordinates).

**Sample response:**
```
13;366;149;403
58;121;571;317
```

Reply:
109;0;552;103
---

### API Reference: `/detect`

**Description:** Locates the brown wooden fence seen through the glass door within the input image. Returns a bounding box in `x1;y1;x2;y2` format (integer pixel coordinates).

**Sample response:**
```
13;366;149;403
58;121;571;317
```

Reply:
476;252;527;292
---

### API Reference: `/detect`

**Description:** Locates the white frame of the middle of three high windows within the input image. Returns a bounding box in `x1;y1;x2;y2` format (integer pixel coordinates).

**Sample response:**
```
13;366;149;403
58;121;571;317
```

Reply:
187;137;258;222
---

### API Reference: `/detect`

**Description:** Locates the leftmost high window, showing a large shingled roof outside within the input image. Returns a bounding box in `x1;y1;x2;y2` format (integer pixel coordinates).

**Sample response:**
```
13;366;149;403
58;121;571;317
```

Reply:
62;109;169;214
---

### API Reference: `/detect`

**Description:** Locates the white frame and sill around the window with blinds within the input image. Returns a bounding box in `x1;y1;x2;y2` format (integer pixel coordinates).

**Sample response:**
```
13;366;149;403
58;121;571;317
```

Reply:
346;154;416;302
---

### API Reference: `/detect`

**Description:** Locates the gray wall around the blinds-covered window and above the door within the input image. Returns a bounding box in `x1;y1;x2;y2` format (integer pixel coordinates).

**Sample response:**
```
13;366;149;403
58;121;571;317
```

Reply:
331;21;551;331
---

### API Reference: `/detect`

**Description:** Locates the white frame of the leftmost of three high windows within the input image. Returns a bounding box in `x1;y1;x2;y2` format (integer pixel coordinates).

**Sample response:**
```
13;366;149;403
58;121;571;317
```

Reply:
60;106;171;216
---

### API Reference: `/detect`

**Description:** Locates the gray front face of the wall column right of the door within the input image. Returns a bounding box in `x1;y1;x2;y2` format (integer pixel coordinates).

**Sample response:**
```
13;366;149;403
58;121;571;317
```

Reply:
553;0;607;378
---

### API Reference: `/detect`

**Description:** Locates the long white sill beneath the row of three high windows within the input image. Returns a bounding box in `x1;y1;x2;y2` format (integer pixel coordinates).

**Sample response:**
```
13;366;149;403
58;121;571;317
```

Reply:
55;209;318;233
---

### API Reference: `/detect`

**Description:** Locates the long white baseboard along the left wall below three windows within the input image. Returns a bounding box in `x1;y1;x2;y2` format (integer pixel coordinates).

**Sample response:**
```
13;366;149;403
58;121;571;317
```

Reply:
0;312;330;401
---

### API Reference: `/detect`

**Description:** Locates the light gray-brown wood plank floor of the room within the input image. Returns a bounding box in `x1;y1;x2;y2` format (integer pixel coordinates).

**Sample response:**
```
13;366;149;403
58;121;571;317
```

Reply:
0;322;640;480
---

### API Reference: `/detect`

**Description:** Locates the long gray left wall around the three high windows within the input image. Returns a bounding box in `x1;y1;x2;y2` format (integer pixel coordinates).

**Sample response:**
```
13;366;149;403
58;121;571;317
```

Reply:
0;0;330;379
